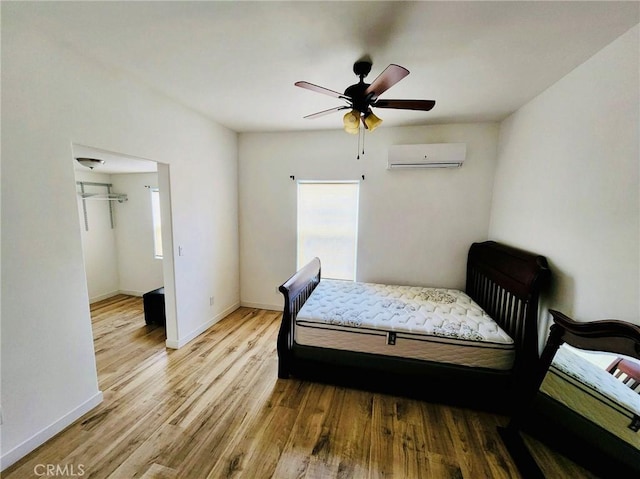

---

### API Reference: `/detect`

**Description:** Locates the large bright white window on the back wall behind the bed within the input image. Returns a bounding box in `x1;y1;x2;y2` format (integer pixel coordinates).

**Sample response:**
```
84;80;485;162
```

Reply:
298;181;360;281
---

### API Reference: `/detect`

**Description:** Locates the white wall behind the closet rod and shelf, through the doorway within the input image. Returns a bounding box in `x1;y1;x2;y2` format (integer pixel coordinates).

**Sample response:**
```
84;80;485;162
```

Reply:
76;171;120;302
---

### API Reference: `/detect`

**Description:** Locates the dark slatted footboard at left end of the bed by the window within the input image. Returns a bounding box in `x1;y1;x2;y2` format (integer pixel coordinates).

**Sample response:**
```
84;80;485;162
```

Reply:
278;258;320;378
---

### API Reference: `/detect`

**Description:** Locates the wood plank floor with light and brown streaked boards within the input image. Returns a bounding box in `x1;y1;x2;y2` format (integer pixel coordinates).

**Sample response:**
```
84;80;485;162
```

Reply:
2;296;594;479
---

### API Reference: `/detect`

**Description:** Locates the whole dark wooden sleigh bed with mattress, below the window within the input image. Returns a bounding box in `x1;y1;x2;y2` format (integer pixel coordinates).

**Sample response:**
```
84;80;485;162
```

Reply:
278;241;550;411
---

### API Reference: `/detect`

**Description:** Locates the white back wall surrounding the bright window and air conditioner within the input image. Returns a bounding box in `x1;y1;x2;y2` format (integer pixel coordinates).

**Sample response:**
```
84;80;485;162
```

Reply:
240;123;498;309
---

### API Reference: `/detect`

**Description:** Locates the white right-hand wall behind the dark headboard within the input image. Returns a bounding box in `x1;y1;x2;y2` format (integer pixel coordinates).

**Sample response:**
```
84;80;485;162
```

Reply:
490;26;640;324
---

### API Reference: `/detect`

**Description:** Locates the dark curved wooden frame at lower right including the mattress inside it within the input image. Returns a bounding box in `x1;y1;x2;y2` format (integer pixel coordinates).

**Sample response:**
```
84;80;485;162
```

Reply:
498;310;640;479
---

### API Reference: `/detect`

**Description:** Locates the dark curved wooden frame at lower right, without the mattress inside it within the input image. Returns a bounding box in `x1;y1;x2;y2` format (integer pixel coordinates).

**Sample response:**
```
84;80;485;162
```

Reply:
498;310;640;479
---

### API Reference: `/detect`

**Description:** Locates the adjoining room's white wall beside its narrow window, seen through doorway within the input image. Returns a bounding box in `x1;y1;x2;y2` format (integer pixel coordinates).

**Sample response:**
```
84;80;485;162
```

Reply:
111;173;164;296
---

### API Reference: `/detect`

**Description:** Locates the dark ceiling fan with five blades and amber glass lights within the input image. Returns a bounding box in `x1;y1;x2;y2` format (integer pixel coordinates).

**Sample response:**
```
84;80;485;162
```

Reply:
295;60;436;135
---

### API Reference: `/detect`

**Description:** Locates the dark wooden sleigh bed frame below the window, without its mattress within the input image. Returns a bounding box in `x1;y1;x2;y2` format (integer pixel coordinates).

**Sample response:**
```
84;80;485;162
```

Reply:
278;241;550;411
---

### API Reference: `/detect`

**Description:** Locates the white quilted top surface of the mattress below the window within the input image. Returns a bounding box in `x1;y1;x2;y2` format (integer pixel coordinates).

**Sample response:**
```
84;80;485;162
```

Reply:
296;279;513;347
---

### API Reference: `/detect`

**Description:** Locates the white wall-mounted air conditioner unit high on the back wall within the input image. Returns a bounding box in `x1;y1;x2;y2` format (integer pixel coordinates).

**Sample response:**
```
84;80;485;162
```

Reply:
387;143;467;170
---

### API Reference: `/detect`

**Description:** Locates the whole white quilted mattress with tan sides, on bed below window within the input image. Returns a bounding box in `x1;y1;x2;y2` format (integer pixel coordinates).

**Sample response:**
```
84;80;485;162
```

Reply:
295;279;515;370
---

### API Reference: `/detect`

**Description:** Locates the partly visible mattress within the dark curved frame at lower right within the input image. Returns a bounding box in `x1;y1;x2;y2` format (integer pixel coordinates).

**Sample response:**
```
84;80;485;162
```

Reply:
540;345;640;449
